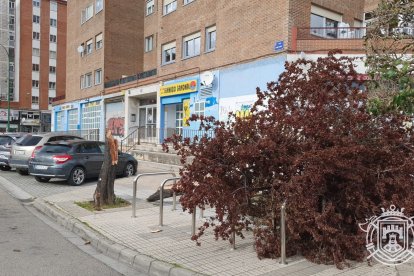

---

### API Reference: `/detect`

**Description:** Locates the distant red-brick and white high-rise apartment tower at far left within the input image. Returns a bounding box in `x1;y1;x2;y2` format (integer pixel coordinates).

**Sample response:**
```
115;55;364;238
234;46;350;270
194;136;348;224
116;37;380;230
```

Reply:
0;0;66;132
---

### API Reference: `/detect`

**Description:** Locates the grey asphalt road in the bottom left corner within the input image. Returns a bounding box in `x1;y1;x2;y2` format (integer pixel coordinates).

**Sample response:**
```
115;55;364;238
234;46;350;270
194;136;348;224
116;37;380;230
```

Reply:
0;186;131;276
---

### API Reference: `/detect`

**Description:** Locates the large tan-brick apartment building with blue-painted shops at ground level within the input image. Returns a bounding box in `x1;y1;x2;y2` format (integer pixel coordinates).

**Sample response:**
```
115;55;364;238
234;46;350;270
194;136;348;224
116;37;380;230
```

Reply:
52;0;388;142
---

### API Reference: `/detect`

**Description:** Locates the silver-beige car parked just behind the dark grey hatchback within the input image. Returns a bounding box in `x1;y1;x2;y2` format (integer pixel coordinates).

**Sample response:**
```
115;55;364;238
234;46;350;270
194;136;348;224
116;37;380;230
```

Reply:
9;132;83;175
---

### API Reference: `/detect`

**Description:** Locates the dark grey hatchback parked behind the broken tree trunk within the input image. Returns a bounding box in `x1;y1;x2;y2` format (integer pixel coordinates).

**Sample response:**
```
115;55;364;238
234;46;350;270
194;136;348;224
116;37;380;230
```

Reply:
29;141;138;186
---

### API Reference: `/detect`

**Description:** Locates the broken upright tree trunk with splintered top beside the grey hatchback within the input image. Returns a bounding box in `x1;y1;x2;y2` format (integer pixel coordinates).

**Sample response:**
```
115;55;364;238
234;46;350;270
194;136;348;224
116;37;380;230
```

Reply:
93;129;118;210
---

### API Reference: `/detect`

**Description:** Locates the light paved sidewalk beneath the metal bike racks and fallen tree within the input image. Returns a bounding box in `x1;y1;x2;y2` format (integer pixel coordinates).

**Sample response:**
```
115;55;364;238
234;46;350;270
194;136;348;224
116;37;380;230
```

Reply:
0;162;414;276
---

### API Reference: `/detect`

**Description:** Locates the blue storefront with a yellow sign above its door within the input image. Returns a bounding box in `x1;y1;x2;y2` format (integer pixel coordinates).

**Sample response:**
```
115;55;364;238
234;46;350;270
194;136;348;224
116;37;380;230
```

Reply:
159;71;219;143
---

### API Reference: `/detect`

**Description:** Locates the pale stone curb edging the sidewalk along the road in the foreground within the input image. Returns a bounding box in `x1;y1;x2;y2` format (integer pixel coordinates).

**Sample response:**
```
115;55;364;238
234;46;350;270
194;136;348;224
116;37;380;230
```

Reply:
33;198;204;276
